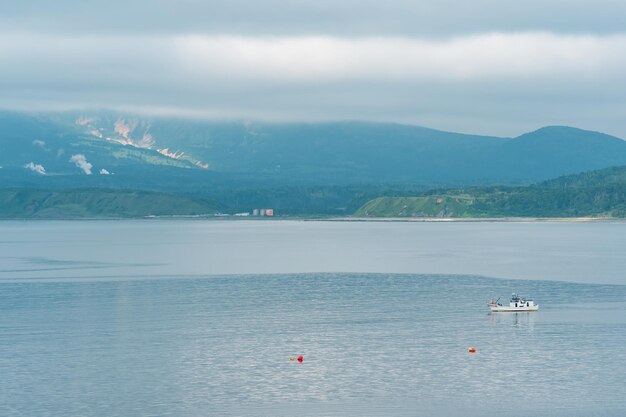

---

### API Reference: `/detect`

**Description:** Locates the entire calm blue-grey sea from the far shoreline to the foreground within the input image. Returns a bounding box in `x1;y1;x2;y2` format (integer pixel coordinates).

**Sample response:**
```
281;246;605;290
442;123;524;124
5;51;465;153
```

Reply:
0;219;626;417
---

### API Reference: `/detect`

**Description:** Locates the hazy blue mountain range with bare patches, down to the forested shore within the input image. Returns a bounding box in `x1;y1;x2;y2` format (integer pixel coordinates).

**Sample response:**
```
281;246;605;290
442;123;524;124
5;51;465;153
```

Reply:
0;112;626;214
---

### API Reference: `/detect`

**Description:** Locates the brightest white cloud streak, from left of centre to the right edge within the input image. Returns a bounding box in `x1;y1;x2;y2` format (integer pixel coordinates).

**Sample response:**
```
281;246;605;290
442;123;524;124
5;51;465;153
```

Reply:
173;33;626;84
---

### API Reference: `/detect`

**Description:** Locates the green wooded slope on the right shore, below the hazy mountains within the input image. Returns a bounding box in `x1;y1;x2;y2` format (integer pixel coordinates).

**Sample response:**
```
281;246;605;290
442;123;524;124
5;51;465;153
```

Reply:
354;167;626;218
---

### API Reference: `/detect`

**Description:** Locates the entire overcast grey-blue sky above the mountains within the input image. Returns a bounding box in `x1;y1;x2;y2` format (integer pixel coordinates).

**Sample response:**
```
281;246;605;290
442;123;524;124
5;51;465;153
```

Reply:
0;0;626;138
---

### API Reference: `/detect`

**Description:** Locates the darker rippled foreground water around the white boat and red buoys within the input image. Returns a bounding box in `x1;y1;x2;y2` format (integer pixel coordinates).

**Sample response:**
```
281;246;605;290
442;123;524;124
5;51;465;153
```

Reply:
0;274;626;417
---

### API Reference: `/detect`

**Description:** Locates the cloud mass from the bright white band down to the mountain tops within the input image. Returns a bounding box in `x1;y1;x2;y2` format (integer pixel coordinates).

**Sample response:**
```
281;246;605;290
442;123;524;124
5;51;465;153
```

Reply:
0;31;626;136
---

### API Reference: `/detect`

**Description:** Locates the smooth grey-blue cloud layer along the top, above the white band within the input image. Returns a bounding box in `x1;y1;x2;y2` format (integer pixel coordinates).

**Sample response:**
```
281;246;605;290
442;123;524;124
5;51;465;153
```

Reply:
0;0;626;37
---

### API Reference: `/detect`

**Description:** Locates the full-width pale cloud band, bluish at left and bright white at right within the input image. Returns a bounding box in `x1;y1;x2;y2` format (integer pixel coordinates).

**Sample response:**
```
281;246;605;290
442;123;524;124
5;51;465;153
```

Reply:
0;32;626;83
